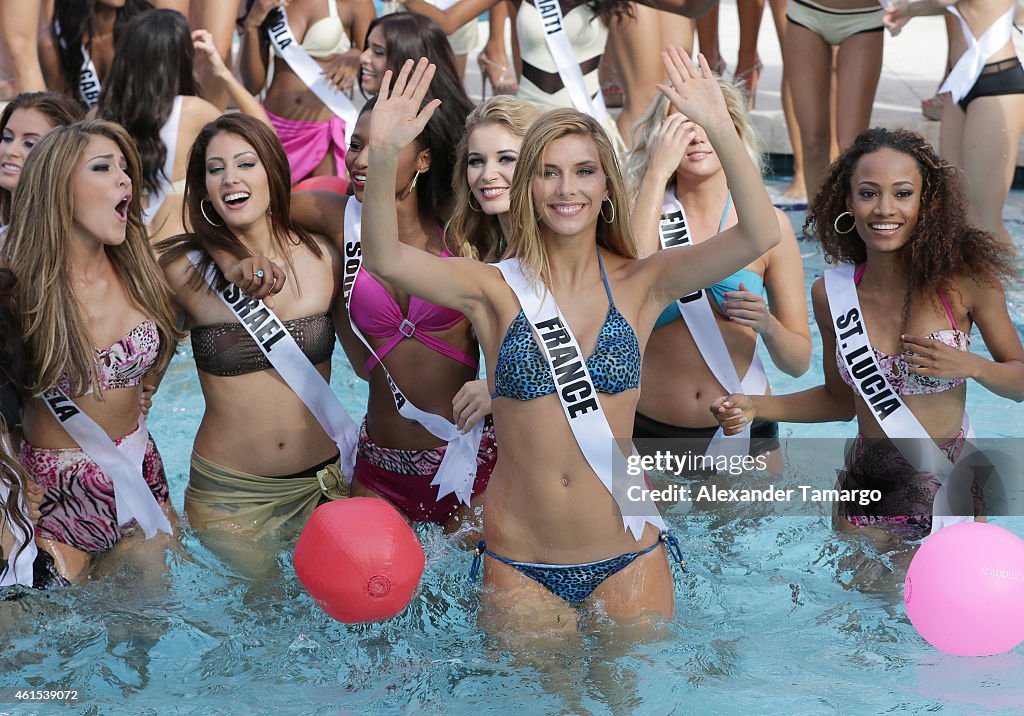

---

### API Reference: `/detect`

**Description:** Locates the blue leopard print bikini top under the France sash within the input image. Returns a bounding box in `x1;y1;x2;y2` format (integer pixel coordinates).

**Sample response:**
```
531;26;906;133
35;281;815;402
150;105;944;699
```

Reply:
492;254;640;401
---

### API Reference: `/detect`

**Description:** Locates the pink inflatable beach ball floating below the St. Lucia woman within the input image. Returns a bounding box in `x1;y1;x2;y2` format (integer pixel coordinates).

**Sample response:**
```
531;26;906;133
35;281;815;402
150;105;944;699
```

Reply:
903;522;1024;657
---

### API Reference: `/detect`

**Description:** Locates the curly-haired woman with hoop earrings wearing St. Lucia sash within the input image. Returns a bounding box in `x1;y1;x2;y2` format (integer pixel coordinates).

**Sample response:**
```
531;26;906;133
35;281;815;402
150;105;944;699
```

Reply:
712;129;1024;538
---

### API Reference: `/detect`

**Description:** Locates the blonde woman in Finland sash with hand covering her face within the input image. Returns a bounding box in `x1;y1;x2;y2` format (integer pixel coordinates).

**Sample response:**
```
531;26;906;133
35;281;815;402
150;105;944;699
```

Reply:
626;79;811;472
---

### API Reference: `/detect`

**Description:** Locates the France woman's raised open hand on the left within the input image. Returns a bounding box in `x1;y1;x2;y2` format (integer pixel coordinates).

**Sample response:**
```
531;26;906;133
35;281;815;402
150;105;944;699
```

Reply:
369;57;441;155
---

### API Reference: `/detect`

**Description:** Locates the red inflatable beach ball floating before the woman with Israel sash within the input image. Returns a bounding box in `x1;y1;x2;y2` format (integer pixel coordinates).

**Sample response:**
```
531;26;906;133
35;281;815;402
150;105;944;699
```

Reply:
294;497;425;624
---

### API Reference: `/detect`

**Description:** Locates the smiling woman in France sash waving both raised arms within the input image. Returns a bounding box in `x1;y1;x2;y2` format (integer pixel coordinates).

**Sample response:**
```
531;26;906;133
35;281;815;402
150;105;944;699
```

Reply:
362;48;778;626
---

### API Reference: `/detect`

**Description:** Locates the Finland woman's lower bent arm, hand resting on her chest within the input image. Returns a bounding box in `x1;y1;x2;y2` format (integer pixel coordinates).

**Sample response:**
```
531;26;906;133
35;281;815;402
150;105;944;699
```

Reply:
722;209;811;377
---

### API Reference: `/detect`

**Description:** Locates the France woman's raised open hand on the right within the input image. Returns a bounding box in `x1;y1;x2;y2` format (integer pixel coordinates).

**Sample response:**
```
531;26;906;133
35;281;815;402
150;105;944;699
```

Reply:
657;45;735;134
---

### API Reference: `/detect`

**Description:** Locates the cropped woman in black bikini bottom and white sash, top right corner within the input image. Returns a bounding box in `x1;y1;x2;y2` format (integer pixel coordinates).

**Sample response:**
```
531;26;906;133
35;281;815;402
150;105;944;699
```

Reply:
886;0;1024;247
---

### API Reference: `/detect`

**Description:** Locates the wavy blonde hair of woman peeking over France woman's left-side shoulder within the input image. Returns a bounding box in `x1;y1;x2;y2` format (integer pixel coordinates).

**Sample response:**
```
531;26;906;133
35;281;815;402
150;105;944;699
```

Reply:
444;94;541;262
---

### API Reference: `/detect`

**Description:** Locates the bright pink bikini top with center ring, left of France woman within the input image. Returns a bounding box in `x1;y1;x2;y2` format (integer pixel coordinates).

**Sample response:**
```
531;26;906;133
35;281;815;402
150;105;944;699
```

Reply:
349;248;478;373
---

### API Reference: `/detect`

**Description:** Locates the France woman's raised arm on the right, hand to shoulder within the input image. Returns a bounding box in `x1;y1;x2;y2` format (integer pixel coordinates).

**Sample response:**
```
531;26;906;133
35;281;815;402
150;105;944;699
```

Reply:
638;47;781;307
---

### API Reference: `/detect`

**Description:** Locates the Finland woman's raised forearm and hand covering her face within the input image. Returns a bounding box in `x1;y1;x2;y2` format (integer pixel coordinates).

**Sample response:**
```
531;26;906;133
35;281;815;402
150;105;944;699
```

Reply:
631;115;692;256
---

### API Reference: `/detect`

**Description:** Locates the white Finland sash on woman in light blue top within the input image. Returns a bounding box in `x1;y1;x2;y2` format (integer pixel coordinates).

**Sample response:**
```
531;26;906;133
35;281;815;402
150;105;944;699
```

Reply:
657;188;768;458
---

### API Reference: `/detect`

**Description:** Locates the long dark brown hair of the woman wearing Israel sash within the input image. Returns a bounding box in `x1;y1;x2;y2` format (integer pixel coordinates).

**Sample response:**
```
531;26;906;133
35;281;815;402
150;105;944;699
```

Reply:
157;114;323;291
